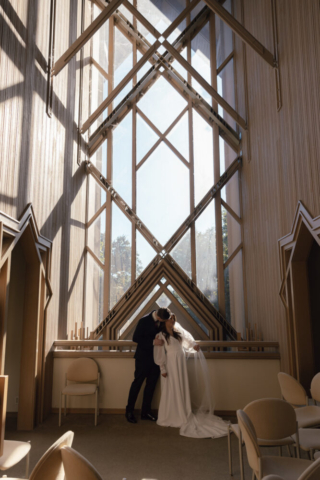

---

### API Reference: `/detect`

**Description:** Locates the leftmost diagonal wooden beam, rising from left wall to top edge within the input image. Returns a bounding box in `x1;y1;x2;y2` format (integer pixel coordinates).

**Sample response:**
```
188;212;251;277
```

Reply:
52;0;122;75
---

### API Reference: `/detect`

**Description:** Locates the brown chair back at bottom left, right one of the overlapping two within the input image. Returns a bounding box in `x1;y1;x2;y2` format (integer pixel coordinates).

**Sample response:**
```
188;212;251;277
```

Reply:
61;447;103;480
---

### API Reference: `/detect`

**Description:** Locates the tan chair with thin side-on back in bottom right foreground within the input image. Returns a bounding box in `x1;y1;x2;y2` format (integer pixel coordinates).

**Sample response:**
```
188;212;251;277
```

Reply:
237;410;312;480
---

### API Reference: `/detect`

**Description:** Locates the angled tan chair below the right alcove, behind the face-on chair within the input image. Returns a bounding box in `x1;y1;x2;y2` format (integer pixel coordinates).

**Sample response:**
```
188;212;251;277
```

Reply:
278;372;320;428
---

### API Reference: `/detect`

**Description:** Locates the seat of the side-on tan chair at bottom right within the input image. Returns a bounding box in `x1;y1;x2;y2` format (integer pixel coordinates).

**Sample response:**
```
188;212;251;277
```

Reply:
261;456;313;480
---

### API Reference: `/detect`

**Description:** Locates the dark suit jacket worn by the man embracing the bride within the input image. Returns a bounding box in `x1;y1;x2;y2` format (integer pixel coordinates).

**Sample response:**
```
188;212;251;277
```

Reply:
132;310;159;362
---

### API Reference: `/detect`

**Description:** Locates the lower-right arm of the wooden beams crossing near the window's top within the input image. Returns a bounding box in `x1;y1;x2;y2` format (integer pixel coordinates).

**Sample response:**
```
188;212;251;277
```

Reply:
163;40;247;130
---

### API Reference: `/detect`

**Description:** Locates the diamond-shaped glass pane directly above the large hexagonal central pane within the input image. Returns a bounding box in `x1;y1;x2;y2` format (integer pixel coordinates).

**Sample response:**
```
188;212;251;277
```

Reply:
138;76;187;133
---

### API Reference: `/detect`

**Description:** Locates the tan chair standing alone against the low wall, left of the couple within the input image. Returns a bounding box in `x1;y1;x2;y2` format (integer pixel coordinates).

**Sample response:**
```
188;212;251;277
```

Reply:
59;358;100;427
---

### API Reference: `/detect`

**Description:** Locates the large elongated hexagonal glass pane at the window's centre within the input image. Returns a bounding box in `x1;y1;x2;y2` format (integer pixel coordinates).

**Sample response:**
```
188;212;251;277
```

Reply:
137;142;190;245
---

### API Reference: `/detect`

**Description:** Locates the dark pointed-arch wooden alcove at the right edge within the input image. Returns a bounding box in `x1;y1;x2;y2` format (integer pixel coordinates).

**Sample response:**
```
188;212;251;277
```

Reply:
279;202;320;389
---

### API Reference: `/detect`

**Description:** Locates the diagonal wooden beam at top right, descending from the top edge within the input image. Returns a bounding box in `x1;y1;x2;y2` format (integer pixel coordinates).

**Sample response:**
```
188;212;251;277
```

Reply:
204;0;277;68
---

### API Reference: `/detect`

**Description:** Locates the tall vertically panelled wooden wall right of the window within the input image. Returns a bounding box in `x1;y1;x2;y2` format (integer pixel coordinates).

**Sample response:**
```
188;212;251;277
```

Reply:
235;0;320;370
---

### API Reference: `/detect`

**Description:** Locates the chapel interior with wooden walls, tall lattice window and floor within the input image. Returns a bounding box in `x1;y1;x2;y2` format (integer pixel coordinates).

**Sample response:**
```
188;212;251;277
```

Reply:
0;0;320;480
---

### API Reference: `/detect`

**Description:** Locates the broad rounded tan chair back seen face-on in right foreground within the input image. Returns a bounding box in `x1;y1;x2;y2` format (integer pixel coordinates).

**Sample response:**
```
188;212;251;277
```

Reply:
243;398;297;440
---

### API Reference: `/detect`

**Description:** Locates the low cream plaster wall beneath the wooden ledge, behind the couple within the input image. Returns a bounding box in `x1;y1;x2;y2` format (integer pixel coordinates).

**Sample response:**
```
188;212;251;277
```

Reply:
52;357;281;410
